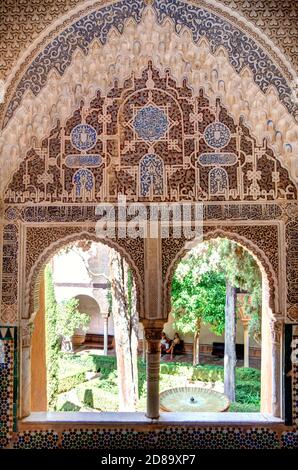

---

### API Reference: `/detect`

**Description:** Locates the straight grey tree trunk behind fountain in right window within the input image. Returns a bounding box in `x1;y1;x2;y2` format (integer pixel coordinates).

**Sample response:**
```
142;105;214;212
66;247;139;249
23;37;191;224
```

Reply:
224;282;236;402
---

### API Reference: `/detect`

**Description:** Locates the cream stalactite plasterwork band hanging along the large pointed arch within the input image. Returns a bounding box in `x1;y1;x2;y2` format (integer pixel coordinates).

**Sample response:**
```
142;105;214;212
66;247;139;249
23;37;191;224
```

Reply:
0;5;297;200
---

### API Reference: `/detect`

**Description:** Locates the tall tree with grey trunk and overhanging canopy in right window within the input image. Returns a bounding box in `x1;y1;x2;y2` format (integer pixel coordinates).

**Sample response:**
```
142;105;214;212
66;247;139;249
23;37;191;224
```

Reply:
173;238;261;401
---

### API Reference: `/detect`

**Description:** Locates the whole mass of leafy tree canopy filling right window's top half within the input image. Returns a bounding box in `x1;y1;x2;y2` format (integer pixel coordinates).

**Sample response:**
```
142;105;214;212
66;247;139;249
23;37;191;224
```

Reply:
172;238;262;340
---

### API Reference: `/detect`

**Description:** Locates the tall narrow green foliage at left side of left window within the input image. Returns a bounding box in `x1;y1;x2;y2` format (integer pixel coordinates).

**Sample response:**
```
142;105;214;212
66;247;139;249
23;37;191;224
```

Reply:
45;266;60;410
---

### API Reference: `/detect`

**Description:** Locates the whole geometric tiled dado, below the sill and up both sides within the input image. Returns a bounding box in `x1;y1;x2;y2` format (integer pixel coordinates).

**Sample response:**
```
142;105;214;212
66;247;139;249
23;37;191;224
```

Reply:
0;327;298;449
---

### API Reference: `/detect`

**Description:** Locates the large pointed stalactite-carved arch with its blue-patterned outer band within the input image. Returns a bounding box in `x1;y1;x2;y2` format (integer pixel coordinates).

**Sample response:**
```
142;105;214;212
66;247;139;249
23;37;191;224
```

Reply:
0;0;298;196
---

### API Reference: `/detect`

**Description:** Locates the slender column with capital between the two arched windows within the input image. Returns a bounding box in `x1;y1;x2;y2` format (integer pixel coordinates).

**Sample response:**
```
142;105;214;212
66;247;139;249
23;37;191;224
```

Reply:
144;322;163;419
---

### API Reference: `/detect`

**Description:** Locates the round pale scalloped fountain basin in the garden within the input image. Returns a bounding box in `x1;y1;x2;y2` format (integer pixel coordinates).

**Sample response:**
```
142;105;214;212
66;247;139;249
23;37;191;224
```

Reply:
159;387;230;412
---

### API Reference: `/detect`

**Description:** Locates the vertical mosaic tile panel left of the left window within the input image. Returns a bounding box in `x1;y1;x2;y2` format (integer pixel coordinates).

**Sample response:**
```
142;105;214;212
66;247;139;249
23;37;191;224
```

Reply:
0;327;17;448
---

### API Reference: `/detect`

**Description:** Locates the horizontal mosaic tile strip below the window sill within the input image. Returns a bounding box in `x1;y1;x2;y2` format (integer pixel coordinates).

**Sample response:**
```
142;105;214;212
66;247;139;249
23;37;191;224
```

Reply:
14;426;288;450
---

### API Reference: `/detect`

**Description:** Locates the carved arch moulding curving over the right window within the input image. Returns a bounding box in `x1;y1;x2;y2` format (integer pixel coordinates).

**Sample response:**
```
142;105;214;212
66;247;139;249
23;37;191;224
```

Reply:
164;227;279;318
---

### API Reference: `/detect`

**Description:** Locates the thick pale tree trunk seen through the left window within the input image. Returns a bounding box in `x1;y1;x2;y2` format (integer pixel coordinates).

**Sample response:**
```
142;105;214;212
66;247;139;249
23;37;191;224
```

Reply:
110;250;138;411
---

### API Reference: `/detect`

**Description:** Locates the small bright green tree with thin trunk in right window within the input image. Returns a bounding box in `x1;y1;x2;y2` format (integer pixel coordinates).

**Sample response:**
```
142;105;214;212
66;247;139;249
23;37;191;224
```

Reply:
172;270;225;365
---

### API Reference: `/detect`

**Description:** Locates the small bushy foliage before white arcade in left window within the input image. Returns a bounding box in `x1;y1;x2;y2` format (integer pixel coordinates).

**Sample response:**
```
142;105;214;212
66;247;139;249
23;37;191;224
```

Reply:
56;298;90;338
